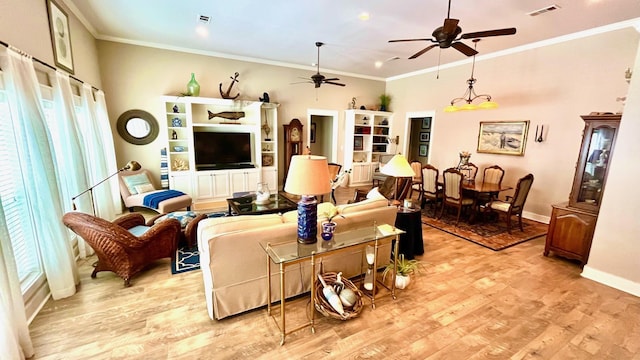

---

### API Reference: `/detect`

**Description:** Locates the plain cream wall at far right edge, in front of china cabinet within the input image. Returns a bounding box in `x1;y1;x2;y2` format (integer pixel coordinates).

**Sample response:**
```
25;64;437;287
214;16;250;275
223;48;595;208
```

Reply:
583;40;640;296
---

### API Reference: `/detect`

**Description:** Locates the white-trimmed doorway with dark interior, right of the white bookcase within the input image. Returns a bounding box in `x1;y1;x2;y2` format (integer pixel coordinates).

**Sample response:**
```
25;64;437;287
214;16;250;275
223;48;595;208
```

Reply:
406;111;435;164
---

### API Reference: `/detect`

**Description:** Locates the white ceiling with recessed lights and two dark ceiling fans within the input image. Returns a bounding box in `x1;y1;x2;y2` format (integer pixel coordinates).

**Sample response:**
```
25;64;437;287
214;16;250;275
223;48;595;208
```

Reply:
63;0;640;78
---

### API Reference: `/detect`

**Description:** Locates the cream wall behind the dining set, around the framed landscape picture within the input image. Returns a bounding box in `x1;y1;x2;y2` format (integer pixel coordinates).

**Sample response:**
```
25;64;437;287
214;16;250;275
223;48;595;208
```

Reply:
387;28;640;217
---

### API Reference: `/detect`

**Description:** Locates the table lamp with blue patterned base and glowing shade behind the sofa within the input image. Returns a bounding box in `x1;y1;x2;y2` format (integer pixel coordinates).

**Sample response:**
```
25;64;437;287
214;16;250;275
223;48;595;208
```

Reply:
284;155;331;244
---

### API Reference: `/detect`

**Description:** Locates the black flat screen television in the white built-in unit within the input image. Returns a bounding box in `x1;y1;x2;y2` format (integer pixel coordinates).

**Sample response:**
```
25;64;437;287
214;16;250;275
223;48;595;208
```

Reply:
193;131;254;170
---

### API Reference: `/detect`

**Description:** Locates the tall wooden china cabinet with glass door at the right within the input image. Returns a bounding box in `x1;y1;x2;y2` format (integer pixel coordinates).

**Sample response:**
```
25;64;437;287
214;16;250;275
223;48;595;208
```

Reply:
544;115;621;265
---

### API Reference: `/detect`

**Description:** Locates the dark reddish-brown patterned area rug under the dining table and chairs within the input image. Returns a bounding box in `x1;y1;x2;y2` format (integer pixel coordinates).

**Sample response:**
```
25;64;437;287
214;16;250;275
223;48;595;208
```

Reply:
422;209;548;251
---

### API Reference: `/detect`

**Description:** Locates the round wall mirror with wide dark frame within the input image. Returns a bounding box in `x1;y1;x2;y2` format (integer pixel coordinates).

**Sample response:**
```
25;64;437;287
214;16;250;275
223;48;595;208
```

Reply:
116;110;159;145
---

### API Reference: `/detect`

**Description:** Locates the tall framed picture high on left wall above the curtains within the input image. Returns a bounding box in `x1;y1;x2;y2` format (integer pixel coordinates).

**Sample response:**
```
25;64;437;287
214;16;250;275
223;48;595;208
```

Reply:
47;0;73;74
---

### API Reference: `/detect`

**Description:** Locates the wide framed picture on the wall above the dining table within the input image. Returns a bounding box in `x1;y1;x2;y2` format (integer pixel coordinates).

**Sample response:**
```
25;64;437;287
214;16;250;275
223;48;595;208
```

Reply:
478;120;529;156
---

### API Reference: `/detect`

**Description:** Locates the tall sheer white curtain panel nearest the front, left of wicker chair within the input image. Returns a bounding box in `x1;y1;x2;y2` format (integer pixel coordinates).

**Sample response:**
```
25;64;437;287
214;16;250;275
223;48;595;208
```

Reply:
0;49;78;299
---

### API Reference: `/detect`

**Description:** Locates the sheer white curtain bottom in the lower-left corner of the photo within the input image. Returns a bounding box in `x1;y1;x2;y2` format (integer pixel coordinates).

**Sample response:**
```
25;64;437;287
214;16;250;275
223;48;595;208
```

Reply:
0;202;34;359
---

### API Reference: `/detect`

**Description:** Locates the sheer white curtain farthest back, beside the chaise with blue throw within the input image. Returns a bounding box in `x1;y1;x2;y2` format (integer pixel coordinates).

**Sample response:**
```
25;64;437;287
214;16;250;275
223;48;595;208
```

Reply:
80;83;120;220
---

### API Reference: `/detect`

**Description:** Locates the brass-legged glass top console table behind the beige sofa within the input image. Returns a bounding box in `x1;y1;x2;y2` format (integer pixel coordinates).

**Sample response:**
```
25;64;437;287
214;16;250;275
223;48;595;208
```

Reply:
260;222;405;345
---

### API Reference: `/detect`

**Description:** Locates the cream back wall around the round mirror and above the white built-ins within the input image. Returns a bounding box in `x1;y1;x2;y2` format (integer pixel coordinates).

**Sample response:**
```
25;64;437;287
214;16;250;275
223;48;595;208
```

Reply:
98;41;385;187
